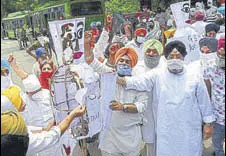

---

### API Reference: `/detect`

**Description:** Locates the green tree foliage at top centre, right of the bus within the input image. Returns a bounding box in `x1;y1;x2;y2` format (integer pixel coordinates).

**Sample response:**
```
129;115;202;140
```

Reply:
105;0;140;14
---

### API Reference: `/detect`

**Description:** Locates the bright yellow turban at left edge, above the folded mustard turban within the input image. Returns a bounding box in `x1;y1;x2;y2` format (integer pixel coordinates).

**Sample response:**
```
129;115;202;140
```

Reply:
2;86;22;110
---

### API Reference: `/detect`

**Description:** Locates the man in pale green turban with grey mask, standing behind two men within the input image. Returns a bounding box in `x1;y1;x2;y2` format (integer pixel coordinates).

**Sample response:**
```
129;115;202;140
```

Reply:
135;40;165;156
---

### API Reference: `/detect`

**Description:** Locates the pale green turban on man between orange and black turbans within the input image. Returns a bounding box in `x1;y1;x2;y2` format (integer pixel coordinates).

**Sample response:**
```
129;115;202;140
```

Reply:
144;39;163;55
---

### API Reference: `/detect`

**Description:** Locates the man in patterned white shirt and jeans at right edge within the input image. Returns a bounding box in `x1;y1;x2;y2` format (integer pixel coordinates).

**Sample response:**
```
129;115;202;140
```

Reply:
204;38;225;156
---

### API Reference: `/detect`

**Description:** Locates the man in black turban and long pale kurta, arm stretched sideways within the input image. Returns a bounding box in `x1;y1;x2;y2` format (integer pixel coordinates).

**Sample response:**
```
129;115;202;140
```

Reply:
118;41;215;156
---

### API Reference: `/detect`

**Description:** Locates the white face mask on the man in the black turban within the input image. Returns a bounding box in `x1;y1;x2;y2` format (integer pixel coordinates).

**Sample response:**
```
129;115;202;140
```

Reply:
167;59;184;74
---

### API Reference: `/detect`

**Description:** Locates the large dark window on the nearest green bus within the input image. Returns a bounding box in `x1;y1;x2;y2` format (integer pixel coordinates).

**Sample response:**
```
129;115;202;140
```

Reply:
71;1;103;17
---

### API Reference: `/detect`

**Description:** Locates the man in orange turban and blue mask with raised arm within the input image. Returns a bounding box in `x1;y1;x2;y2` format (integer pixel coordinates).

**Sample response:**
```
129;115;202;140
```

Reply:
85;42;148;156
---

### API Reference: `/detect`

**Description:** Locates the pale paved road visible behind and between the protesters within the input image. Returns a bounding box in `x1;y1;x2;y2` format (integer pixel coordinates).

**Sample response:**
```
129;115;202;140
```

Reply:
1;40;214;156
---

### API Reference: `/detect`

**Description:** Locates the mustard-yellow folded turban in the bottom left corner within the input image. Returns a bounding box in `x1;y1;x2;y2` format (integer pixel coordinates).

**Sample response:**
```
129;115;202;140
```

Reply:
1;111;28;136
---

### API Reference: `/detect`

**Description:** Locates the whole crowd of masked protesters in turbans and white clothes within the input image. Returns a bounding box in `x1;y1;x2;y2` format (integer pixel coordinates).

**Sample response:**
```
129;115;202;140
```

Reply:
1;1;225;156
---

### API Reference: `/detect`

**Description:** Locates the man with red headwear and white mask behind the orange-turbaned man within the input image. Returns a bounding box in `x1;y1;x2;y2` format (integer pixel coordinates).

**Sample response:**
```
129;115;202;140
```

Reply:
126;24;147;61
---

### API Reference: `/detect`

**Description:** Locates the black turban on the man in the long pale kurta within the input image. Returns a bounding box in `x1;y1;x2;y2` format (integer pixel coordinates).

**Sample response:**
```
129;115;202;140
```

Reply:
164;40;187;58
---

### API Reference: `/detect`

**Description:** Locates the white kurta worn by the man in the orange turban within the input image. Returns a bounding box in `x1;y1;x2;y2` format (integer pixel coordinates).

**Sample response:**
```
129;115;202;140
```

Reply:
91;60;148;156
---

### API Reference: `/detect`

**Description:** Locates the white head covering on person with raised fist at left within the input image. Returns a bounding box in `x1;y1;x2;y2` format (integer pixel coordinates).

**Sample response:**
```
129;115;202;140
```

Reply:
23;75;42;93
